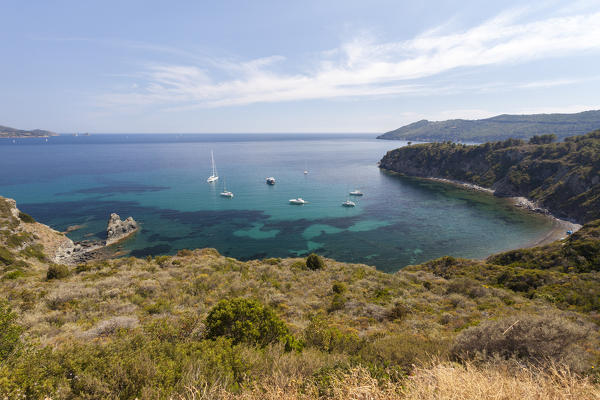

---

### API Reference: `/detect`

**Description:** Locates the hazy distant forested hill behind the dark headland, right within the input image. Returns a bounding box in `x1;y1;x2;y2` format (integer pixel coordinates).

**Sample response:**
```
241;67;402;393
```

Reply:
377;110;600;143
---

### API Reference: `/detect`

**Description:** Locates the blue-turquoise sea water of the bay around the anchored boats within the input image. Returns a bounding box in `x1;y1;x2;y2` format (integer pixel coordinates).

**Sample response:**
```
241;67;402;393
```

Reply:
0;134;551;271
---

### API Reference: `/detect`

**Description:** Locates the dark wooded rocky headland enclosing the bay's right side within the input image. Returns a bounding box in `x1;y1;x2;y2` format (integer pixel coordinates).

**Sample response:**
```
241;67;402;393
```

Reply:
379;130;600;223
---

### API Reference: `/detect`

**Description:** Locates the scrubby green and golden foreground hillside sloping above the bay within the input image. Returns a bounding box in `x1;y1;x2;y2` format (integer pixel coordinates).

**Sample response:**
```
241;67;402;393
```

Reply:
0;198;600;399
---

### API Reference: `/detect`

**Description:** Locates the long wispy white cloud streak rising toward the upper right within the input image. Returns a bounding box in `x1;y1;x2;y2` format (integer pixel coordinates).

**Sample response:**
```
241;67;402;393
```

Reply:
101;9;600;109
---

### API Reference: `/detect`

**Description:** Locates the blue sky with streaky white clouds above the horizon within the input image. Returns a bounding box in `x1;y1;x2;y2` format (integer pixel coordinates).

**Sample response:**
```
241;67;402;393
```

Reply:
0;0;600;133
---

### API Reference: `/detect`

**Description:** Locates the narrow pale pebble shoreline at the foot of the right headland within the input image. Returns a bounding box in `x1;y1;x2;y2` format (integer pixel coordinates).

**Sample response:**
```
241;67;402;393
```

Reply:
423;178;582;248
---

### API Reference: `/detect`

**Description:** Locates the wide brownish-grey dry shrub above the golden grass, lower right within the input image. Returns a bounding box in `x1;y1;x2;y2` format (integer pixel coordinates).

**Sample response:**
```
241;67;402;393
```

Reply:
451;315;589;370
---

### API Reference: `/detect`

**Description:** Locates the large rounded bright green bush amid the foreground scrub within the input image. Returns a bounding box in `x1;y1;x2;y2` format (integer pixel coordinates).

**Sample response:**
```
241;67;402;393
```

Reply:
205;298;288;347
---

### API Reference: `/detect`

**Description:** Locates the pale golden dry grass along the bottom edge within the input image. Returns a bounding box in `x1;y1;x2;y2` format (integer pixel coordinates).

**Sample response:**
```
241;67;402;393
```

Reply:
179;363;600;400
